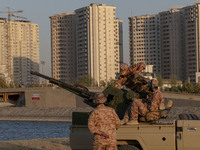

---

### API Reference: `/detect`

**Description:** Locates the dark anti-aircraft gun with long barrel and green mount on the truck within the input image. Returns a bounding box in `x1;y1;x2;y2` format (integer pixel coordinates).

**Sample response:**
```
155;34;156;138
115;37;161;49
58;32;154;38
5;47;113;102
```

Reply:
30;72;136;119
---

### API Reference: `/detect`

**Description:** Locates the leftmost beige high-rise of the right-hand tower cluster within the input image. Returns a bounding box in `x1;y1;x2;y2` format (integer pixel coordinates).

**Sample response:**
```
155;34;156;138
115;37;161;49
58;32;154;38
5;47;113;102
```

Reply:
129;15;161;74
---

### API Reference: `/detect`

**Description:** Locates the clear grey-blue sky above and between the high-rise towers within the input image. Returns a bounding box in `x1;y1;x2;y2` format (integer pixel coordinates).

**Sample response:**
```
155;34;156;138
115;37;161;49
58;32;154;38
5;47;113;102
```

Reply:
0;0;198;76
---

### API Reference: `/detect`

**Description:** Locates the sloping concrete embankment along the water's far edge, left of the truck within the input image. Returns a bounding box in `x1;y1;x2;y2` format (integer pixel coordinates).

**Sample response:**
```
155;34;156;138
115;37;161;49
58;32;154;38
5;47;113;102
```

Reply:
0;107;91;122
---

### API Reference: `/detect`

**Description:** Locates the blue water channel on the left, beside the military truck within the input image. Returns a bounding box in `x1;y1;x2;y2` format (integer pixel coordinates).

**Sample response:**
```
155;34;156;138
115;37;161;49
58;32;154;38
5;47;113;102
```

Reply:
0;121;71;141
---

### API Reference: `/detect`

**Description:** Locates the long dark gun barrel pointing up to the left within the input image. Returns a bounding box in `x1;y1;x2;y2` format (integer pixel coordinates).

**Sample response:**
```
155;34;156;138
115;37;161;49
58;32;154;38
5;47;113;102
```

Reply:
30;71;96;100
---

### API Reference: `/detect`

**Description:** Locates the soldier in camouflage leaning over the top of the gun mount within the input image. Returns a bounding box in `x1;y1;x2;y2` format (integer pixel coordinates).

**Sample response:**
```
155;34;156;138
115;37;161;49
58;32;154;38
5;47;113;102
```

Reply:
115;62;146;90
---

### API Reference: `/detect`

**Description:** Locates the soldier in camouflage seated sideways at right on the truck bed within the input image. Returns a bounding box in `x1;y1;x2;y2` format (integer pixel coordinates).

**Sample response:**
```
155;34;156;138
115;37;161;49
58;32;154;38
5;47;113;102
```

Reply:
121;79;164;125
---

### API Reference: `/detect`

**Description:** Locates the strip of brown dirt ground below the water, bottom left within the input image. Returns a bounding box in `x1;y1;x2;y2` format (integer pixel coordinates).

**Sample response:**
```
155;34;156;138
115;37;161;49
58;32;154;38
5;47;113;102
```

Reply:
0;138;71;150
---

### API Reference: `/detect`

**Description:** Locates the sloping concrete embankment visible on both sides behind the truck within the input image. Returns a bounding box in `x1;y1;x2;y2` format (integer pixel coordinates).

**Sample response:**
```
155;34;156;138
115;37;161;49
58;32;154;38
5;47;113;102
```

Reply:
0;93;200;122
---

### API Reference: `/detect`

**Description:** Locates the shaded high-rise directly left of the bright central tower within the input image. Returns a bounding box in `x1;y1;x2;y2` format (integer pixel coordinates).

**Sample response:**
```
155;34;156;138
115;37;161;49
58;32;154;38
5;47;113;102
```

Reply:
50;13;76;83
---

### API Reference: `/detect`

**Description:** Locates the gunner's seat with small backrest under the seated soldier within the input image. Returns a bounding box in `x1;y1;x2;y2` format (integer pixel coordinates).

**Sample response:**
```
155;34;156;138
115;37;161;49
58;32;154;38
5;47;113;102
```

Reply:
139;100;173;122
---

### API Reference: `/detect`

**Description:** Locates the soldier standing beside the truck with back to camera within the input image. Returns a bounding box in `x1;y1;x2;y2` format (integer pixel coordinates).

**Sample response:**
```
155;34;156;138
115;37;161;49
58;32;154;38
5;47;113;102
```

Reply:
88;93;120;150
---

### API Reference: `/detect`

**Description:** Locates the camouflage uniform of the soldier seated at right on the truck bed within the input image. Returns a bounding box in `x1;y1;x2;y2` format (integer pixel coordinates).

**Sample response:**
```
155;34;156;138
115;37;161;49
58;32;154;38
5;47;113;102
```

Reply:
130;90;164;121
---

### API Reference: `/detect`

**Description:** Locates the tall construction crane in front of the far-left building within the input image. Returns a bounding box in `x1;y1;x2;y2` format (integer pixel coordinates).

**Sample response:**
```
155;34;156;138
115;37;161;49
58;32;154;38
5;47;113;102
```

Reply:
0;7;24;81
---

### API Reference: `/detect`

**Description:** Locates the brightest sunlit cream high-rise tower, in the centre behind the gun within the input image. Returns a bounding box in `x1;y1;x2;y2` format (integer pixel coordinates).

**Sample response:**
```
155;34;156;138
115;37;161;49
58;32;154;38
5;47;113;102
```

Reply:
75;4;123;85
